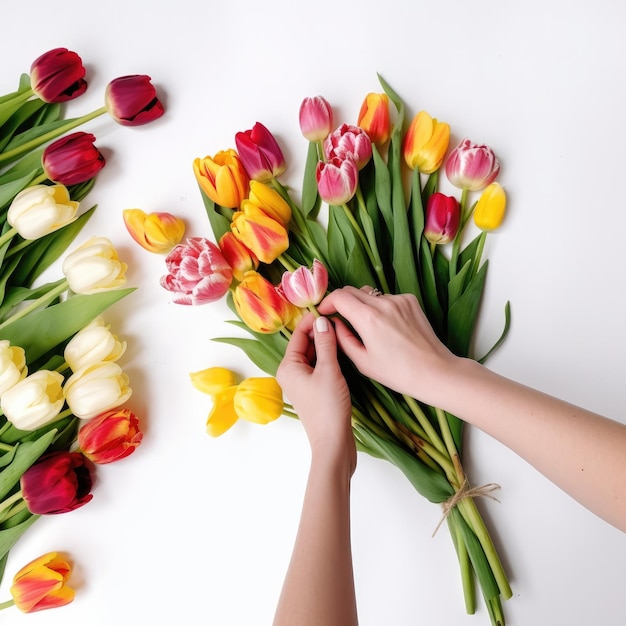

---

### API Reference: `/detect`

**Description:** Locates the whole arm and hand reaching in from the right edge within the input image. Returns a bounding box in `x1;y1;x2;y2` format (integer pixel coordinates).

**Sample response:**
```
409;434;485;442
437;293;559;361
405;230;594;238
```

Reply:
318;287;626;532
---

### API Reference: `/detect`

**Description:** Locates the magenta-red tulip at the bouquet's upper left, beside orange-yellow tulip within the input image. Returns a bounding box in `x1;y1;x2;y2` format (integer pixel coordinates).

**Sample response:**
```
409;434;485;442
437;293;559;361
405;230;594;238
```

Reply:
235;122;286;182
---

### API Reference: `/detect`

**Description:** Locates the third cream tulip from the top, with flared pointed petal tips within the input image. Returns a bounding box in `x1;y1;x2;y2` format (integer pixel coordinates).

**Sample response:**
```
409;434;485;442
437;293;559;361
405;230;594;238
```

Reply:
63;316;126;372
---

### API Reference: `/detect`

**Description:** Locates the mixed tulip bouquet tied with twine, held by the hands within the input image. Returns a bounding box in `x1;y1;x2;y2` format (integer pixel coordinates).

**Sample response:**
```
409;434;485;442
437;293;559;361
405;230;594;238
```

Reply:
161;77;512;625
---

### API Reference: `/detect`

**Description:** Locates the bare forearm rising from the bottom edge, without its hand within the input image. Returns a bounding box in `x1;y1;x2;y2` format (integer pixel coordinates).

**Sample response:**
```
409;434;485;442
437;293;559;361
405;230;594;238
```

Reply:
274;455;358;626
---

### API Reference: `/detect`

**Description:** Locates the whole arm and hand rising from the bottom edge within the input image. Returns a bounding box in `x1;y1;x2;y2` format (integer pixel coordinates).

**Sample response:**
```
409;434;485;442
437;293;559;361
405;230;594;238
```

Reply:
274;315;358;626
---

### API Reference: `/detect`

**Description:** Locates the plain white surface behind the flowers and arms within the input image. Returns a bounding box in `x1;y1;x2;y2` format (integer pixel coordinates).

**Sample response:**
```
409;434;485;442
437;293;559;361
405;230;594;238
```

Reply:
0;0;626;626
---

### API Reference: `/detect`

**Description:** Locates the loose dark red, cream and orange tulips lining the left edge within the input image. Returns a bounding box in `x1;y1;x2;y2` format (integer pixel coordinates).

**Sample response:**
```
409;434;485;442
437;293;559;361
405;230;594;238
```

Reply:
0;48;163;612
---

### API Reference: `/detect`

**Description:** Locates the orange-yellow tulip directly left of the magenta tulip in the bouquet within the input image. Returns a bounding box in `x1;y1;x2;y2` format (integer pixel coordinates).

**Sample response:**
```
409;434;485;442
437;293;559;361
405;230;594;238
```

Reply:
193;149;250;209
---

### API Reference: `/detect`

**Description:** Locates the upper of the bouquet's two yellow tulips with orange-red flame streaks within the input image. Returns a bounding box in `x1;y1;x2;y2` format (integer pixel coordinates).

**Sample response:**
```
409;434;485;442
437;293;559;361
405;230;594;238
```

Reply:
230;202;289;263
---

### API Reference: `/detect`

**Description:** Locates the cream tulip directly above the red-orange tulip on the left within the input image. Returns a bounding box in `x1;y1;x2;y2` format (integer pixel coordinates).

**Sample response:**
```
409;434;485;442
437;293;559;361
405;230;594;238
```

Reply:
63;362;132;419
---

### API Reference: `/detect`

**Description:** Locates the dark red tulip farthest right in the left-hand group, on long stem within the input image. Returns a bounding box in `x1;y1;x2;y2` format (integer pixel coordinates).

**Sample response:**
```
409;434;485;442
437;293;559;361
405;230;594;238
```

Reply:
104;74;164;126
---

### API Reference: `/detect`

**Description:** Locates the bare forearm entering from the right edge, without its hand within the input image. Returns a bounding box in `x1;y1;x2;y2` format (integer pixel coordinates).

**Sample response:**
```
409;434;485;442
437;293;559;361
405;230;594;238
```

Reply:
438;359;626;531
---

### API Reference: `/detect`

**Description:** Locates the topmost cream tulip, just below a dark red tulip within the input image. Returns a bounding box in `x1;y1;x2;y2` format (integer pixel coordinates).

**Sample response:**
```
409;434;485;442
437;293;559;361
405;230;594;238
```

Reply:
7;185;78;240
